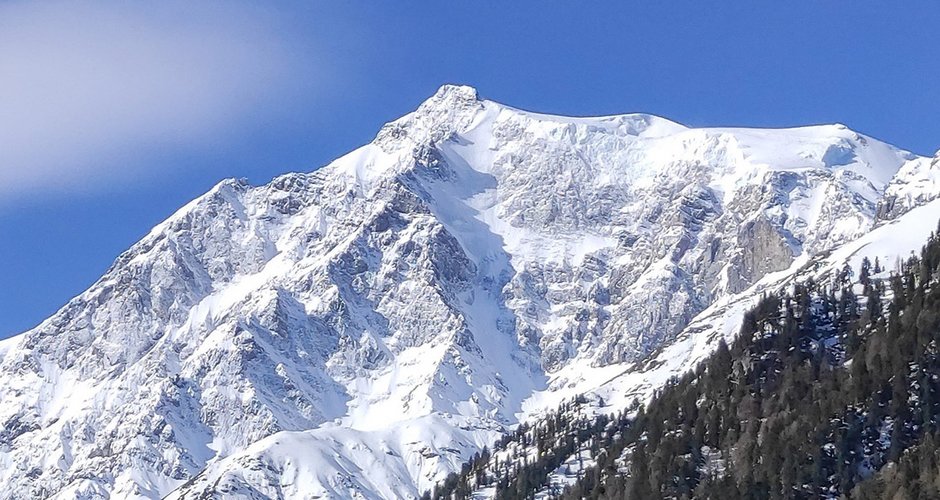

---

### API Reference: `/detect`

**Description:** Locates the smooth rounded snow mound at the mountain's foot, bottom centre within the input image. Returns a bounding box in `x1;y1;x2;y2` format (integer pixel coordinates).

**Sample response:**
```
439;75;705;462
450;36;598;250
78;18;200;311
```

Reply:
168;415;500;500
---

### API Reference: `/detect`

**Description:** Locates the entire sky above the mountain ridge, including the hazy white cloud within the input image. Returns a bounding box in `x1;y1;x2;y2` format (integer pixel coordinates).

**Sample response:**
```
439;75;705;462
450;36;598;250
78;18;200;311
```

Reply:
0;1;940;337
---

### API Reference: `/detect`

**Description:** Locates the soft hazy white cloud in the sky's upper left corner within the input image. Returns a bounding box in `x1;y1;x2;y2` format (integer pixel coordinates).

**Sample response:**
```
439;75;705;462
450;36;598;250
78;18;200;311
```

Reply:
0;2;322;201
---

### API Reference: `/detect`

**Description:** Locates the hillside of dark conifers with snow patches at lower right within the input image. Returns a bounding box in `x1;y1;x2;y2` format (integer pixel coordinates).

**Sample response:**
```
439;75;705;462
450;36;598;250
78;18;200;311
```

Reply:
436;223;940;499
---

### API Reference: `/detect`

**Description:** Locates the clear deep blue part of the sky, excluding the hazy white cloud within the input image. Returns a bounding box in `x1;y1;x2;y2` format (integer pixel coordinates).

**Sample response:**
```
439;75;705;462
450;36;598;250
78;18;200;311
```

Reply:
0;1;940;338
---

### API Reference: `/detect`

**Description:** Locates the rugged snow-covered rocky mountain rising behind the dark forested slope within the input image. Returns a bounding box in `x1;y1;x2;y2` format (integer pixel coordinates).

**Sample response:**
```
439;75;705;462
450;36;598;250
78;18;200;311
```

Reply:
0;86;940;498
